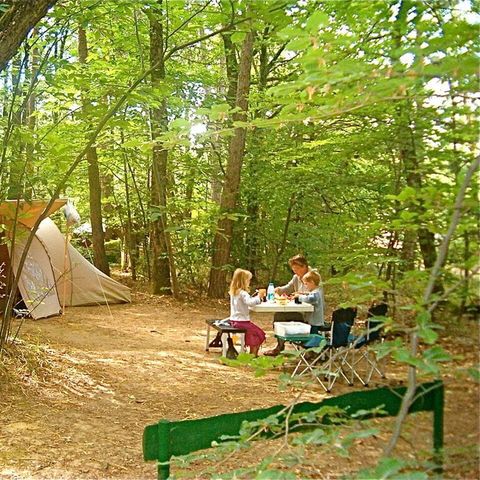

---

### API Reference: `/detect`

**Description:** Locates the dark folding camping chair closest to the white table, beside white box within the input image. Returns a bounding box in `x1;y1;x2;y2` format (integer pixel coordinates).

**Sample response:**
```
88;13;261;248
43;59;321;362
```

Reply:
278;308;357;392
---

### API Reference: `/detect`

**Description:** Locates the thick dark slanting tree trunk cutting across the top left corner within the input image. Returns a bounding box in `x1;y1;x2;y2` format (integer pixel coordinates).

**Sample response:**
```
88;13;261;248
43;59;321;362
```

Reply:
0;0;57;71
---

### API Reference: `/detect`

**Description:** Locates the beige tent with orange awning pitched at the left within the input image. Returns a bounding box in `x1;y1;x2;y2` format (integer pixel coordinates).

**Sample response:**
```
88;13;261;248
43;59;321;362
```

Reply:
0;200;131;318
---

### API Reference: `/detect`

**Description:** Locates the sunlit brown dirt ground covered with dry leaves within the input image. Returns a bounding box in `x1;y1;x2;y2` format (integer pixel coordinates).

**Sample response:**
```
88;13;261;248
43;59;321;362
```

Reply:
0;293;480;480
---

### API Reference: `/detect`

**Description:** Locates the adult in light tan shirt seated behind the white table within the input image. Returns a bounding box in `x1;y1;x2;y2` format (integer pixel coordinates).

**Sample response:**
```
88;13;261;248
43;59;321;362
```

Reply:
265;255;312;357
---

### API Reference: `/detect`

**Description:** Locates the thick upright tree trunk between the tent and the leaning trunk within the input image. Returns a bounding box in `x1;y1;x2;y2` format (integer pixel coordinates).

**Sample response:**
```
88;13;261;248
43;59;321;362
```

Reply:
150;9;178;296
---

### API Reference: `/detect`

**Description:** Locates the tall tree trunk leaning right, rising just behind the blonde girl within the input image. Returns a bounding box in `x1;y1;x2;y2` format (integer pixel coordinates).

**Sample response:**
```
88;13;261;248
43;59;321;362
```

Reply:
208;32;254;298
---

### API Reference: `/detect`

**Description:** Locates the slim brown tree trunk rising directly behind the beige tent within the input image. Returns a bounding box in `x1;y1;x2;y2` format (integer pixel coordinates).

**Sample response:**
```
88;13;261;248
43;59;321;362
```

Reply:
78;27;110;275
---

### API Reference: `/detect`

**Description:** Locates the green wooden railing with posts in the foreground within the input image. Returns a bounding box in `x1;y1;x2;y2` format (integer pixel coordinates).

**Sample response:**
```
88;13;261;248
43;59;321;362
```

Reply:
143;381;444;480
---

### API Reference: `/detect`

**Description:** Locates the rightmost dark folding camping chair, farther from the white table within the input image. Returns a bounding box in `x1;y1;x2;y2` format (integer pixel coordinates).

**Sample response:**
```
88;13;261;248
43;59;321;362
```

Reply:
349;303;388;387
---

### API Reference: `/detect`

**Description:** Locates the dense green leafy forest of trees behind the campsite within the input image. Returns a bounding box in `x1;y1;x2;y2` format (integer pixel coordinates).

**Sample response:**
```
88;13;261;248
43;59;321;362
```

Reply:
0;0;479;304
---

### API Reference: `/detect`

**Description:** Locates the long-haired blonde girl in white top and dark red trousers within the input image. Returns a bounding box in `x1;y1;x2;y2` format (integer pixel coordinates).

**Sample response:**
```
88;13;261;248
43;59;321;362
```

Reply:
228;268;266;356
